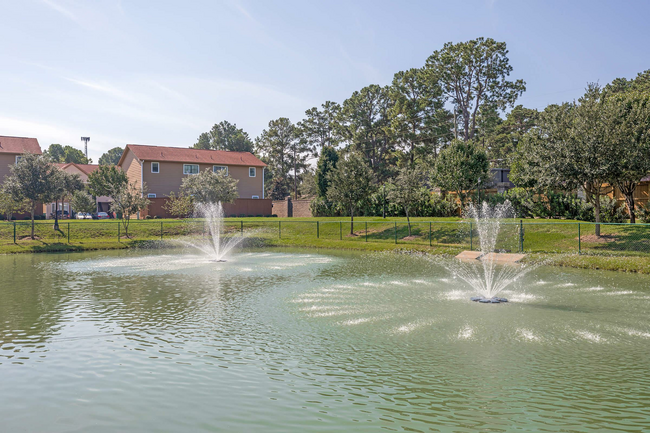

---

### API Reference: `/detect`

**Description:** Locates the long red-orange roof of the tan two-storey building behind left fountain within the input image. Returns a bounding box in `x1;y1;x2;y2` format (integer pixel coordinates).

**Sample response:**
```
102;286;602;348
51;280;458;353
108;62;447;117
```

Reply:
117;144;266;167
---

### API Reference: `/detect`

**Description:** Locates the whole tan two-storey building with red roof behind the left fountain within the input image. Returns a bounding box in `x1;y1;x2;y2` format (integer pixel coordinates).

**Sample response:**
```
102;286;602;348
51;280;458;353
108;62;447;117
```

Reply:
117;144;271;216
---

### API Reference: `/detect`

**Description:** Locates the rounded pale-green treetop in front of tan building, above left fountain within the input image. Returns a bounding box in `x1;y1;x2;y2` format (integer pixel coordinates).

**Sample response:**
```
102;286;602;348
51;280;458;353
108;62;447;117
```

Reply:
180;170;239;203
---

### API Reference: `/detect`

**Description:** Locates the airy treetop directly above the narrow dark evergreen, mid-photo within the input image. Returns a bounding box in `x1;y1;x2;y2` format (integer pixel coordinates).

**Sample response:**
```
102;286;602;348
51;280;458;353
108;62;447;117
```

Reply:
297;101;341;157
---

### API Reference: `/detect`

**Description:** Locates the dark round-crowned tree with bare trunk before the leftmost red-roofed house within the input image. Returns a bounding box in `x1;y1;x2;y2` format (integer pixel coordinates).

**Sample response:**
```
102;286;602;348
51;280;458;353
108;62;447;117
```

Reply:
4;153;58;239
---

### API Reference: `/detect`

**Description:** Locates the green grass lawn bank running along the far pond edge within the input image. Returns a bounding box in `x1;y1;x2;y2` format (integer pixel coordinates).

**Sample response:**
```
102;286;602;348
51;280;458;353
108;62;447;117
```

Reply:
0;217;650;273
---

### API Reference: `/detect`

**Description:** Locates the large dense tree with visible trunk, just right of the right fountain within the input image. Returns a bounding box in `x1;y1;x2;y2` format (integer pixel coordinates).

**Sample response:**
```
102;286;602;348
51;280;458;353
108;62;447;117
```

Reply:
510;84;618;236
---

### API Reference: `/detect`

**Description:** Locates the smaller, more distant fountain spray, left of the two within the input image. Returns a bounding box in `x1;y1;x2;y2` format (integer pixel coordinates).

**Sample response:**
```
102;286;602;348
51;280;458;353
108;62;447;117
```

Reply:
183;202;243;262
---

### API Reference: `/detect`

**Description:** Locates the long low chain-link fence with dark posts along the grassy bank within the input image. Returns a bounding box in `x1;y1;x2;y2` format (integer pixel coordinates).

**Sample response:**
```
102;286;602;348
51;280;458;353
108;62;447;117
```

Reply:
0;218;650;255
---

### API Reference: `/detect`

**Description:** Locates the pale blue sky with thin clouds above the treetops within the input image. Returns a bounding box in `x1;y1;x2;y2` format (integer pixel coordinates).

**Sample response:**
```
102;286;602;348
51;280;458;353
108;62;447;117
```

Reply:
0;0;650;162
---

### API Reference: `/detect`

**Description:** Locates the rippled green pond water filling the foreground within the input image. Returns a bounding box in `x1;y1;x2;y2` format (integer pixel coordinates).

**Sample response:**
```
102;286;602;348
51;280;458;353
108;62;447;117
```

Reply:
0;249;650;432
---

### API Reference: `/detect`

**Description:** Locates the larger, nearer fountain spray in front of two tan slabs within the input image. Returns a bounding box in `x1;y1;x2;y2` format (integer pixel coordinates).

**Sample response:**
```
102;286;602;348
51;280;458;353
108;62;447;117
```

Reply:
447;201;534;304
